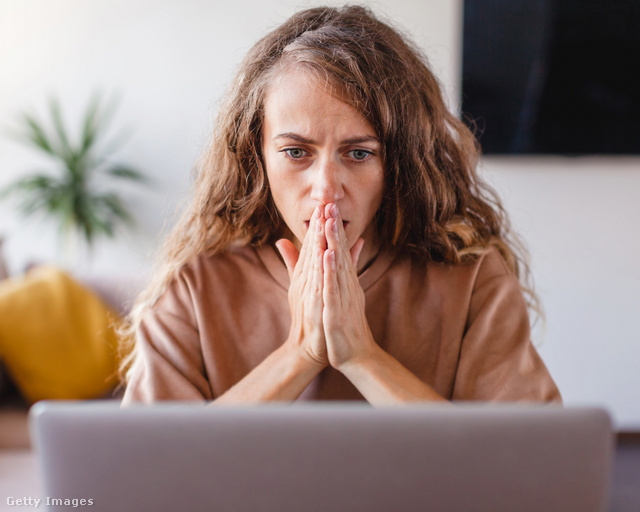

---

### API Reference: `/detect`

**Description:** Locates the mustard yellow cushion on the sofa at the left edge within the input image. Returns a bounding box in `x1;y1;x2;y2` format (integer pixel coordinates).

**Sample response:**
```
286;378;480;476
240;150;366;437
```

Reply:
0;266;118;403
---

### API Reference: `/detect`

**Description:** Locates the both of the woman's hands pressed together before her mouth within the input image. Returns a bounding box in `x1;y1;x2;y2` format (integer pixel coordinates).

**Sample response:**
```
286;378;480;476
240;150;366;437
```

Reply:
276;203;377;370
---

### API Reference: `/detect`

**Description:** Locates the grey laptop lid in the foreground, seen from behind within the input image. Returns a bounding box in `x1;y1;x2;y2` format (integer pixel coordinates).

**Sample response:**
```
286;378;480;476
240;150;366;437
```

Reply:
30;401;614;512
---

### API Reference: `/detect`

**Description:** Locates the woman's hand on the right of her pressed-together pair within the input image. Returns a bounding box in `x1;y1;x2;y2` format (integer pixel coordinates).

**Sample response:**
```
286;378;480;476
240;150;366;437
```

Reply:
322;204;378;370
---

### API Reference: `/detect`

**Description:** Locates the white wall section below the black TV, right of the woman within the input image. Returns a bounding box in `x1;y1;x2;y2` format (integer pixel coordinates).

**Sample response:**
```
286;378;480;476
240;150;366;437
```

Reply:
483;158;640;429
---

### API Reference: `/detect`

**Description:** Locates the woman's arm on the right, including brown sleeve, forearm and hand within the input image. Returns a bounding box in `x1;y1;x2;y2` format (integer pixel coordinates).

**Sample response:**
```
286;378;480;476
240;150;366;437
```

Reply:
323;204;561;403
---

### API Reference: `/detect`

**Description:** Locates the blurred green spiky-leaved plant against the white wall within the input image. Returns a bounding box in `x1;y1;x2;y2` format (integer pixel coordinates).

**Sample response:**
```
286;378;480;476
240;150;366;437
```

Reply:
0;95;146;263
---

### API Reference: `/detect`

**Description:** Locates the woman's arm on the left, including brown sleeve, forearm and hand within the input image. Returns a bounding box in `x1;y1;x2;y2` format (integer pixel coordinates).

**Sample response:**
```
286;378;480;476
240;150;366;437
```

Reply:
123;206;328;405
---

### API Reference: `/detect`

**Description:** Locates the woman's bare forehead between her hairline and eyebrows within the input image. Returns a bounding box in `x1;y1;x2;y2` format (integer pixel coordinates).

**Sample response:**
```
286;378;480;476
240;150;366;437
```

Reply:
264;69;376;135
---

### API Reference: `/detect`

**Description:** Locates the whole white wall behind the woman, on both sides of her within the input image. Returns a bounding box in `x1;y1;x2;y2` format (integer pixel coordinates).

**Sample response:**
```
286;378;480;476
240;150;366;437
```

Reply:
0;0;640;428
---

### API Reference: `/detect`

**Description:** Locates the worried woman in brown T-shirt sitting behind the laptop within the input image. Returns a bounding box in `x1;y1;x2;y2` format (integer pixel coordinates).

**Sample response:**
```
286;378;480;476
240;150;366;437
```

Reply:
124;7;560;404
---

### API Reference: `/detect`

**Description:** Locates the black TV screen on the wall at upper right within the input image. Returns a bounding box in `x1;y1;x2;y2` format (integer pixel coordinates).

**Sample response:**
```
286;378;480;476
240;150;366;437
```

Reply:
462;0;640;155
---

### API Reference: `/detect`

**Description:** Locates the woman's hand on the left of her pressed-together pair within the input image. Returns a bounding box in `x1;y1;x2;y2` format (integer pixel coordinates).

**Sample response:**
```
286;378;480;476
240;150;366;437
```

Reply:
276;207;329;368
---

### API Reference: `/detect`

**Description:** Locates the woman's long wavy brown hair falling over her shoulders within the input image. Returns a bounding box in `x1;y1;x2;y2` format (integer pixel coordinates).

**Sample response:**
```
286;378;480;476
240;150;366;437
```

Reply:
121;6;540;380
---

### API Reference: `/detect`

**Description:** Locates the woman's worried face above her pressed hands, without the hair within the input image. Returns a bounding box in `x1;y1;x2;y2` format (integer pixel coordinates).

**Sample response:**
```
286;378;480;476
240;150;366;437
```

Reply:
262;71;383;266
